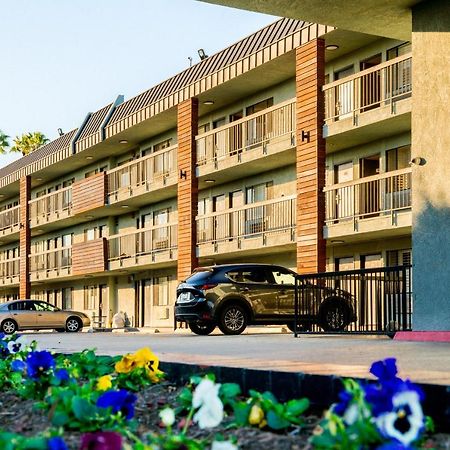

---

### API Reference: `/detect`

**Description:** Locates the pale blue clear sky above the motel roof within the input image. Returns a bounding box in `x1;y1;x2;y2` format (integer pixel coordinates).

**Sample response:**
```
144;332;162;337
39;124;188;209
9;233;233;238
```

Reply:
0;0;277;167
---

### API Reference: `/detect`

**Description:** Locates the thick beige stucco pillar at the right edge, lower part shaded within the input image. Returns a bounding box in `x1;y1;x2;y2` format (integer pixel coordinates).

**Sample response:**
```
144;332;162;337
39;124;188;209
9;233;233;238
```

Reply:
411;0;450;331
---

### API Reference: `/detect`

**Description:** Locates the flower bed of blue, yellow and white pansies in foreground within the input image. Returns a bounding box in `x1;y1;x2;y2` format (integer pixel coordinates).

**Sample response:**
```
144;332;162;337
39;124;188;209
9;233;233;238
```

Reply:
0;336;450;450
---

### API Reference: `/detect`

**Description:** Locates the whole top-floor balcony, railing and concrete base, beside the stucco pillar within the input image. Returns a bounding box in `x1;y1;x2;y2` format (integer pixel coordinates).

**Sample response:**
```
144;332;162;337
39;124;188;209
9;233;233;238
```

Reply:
323;54;412;151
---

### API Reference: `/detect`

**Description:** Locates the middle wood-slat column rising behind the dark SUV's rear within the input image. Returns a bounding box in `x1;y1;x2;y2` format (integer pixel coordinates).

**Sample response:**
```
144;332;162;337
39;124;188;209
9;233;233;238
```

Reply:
178;98;198;281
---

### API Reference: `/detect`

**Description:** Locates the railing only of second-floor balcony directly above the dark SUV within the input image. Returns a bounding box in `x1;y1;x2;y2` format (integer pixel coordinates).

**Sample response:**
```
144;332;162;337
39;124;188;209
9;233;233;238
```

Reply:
197;197;296;244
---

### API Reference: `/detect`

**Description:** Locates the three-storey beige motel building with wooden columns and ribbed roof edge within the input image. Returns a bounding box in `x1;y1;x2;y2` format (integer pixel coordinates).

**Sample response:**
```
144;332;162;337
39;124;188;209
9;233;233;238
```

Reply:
0;1;444;329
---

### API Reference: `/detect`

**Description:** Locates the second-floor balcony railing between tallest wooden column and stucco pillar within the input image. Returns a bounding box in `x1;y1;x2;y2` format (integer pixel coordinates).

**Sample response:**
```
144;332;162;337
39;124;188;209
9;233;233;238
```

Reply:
324;168;411;225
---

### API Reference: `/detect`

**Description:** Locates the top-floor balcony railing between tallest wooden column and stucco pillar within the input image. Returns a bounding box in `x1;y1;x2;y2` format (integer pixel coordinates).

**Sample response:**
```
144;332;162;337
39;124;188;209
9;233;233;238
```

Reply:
323;54;412;124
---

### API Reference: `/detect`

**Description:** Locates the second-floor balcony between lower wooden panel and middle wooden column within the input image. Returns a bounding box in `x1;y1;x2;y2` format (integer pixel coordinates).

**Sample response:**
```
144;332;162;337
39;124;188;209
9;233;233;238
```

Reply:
108;224;178;270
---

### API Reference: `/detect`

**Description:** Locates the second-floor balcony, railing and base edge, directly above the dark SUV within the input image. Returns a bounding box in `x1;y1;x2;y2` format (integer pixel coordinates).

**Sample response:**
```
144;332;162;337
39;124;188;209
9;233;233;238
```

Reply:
197;196;296;256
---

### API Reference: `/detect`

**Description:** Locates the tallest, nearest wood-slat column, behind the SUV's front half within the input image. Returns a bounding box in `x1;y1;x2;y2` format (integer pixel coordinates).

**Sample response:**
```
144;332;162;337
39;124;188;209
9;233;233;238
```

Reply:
296;39;326;273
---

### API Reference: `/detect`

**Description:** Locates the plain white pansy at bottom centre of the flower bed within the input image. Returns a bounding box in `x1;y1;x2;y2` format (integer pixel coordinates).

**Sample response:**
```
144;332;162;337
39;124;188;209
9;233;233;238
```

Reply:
192;378;223;429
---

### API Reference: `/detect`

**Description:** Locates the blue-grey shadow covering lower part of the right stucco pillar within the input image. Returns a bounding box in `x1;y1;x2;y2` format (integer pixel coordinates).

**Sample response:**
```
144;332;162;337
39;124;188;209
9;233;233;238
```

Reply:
412;202;450;330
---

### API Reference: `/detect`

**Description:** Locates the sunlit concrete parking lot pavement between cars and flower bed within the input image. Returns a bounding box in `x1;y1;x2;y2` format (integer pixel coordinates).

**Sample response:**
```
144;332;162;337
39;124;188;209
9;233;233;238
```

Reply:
23;328;450;385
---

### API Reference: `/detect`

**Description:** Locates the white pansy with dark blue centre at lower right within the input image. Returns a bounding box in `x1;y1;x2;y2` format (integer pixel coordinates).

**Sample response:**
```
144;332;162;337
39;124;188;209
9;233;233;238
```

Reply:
375;391;424;446
